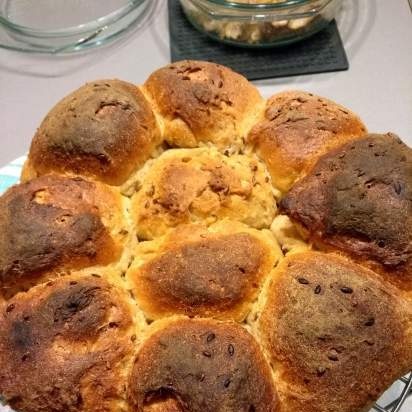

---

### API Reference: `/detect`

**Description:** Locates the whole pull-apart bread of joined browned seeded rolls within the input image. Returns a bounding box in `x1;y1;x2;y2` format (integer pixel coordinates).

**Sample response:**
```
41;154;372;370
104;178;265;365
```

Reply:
0;61;412;412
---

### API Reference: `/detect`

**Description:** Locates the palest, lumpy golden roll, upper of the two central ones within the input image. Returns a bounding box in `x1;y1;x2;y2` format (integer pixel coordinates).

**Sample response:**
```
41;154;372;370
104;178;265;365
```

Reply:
132;148;276;239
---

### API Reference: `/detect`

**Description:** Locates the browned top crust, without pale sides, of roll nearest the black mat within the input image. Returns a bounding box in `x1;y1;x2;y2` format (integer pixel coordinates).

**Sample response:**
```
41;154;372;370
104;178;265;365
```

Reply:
144;60;261;141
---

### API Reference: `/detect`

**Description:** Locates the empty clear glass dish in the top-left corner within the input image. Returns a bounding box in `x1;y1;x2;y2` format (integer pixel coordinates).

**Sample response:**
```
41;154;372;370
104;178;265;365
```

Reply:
0;0;154;53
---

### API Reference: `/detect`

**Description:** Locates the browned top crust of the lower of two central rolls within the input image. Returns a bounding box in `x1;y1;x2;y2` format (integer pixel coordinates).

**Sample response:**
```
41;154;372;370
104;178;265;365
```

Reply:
135;233;265;315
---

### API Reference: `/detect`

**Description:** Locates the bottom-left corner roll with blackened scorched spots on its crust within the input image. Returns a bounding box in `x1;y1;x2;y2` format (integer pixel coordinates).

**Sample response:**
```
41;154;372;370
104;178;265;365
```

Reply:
0;276;134;412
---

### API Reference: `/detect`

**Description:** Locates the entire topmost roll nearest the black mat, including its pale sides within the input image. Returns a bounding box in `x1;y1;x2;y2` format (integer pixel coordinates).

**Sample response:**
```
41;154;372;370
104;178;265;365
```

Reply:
144;60;263;149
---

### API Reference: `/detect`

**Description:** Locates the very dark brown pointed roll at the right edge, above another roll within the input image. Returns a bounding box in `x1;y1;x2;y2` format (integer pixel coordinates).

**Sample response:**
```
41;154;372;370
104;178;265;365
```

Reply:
281;134;412;289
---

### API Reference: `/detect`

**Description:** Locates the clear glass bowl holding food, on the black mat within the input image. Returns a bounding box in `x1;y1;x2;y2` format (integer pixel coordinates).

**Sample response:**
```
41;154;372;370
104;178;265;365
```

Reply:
180;0;341;47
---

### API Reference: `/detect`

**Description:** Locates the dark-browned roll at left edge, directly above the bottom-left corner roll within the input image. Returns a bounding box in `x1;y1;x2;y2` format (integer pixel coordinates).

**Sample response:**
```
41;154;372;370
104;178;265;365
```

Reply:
0;176;125;297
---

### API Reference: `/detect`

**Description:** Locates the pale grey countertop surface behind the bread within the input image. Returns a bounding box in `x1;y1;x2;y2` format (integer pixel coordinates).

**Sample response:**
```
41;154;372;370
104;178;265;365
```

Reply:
0;0;412;412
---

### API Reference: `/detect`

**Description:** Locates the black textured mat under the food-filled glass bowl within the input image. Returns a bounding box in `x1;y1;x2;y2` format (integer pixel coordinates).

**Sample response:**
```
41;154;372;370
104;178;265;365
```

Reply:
168;0;349;80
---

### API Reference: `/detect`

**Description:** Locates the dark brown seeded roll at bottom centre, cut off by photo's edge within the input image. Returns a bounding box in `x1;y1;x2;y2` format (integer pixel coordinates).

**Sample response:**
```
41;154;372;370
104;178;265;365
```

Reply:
129;319;279;412
